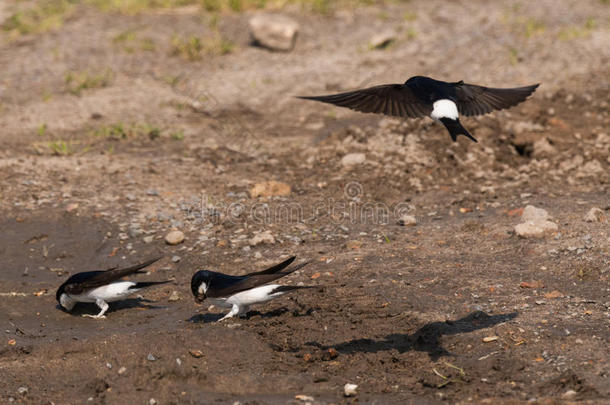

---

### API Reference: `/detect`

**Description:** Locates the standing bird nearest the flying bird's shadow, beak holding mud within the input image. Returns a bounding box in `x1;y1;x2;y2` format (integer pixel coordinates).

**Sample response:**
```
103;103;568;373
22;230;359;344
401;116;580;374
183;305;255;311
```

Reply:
191;256;315;321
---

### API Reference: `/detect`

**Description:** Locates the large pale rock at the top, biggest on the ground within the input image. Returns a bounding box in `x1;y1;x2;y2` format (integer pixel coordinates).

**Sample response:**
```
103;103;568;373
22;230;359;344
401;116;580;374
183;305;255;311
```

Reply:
249;14;299;51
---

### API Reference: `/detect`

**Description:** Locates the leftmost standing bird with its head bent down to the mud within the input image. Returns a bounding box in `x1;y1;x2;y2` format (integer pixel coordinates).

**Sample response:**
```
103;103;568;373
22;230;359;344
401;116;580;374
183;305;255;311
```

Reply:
55;257;171;319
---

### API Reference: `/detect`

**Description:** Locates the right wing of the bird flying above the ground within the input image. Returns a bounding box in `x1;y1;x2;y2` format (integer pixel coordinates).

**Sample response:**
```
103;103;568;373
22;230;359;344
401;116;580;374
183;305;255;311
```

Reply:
455;83;539;116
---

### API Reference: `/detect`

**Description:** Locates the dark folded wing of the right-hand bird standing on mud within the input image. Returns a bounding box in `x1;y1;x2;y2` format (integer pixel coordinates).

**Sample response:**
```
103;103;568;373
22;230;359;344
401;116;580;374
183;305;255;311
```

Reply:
206;259;309;298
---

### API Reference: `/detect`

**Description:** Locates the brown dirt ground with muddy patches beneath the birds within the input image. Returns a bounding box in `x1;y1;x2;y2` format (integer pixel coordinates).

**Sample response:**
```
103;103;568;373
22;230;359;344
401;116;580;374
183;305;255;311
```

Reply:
0;0;610;405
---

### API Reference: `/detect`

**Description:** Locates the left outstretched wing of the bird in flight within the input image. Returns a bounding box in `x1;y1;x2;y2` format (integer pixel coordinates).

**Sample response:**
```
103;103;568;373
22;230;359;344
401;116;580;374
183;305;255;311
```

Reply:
299;84;432;118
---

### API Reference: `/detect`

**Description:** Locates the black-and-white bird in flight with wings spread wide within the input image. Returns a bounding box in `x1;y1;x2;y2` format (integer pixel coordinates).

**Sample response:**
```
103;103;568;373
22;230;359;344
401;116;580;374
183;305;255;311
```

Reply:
298;76;539;142
